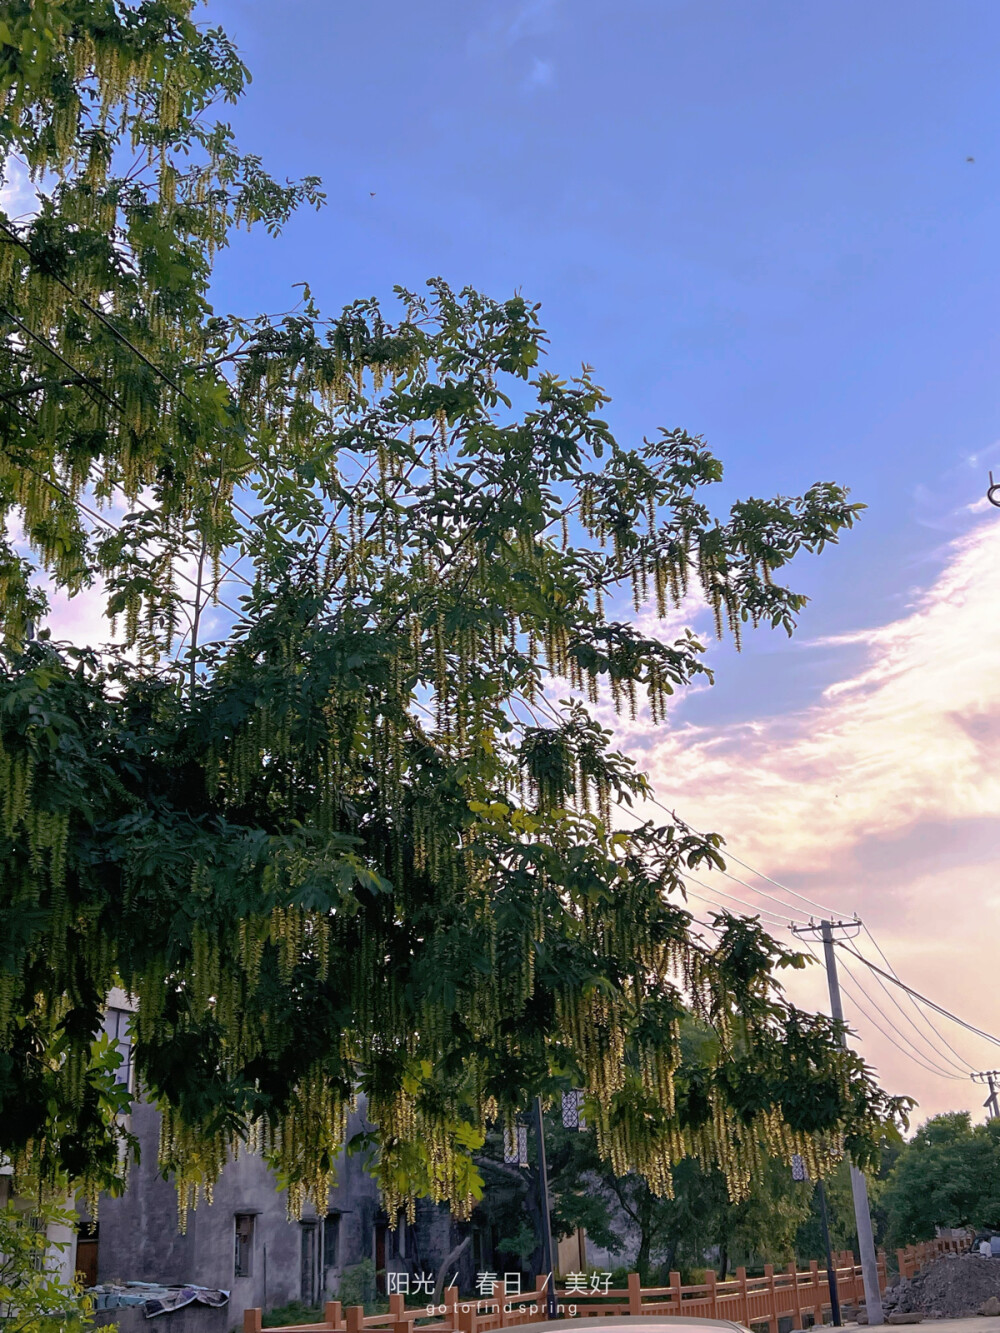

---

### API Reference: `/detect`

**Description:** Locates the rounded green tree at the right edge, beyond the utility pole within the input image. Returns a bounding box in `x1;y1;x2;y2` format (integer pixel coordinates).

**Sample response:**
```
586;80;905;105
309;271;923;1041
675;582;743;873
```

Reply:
883;1110;1000;1245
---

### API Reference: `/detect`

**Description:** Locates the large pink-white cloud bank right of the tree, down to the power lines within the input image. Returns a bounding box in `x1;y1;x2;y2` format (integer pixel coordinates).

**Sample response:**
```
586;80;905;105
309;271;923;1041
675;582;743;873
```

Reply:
616;517;1000;1114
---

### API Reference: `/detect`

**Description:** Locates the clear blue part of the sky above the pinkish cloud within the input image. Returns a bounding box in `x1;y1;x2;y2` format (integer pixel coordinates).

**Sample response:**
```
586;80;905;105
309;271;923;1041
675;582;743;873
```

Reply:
208;0;1000;718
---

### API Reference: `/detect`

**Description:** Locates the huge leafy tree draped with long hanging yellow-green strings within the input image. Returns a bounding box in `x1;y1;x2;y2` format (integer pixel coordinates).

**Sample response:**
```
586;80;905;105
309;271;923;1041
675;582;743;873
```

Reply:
0;0;903;1216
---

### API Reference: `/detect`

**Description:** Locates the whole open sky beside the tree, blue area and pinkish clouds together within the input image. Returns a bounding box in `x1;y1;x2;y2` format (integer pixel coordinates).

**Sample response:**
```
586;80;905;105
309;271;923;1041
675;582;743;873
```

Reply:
23;0;1000;1118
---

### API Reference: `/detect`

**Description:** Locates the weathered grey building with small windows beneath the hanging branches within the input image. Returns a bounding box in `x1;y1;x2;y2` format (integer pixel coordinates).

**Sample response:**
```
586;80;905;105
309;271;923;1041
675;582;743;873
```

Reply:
76;992;475;1329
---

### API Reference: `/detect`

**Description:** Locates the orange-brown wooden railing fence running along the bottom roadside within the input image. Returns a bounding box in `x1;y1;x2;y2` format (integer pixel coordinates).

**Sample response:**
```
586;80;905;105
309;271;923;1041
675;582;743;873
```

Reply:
243;1240;963;1333
